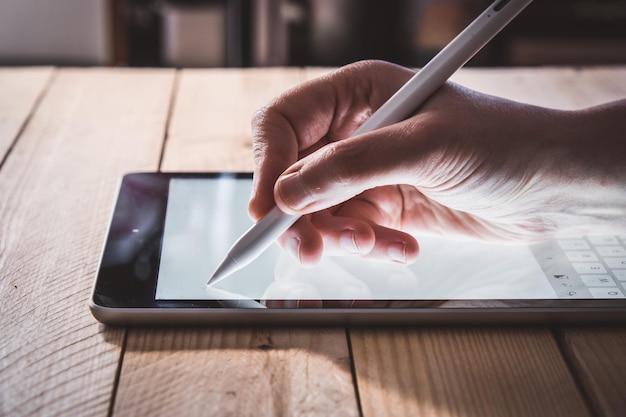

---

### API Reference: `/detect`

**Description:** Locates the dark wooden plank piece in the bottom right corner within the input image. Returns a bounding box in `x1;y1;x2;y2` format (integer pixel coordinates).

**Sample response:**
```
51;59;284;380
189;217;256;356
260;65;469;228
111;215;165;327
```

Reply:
562;326;626;417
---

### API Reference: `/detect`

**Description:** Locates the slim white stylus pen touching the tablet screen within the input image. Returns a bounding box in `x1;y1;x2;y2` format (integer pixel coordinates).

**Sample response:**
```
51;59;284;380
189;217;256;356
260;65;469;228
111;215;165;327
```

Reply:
207;0;532;285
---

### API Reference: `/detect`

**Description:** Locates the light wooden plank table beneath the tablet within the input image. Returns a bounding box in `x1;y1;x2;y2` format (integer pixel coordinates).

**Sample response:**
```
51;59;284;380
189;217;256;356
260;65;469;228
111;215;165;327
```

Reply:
0;67;626;417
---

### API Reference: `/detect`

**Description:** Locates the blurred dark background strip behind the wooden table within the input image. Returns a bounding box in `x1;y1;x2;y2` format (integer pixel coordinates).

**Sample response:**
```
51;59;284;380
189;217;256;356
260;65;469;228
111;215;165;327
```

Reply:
0;0;626;67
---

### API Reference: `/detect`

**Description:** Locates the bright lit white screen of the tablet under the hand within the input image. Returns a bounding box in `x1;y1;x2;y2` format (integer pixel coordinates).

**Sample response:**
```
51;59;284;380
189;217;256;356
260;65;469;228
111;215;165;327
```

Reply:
155;176;626;300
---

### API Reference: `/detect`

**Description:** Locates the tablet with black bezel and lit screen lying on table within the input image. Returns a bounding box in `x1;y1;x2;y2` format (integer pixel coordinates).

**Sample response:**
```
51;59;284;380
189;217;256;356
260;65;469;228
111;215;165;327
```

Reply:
90;173;626;325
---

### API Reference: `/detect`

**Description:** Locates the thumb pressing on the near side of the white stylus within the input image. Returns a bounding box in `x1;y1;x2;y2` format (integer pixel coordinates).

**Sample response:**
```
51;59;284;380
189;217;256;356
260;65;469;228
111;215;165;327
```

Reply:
274;125;417;215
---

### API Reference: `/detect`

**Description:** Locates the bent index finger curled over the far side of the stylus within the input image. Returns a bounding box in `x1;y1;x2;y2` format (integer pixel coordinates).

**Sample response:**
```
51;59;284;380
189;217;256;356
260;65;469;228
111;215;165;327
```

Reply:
248;61;412;220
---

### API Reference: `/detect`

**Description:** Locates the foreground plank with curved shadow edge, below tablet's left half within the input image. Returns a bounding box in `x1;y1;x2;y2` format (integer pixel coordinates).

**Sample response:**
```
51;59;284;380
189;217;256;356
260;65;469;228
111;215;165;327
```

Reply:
114;329;357;416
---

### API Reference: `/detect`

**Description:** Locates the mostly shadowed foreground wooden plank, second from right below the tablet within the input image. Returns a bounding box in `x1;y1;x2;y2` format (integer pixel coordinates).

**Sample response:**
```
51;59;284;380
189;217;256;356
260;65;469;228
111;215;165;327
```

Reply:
351;328;590;417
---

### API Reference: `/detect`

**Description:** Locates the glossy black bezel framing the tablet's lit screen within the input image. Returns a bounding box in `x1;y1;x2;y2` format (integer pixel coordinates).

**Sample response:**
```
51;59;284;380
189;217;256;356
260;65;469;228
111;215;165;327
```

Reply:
91;172;626;324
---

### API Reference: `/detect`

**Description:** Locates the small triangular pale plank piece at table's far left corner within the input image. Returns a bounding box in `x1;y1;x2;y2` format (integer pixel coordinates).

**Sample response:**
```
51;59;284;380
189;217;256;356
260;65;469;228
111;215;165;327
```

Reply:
0;67;54;161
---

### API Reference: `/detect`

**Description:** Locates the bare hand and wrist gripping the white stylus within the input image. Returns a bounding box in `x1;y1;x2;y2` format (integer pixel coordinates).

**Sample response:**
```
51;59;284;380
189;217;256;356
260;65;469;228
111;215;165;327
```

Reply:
249;61;626;265
